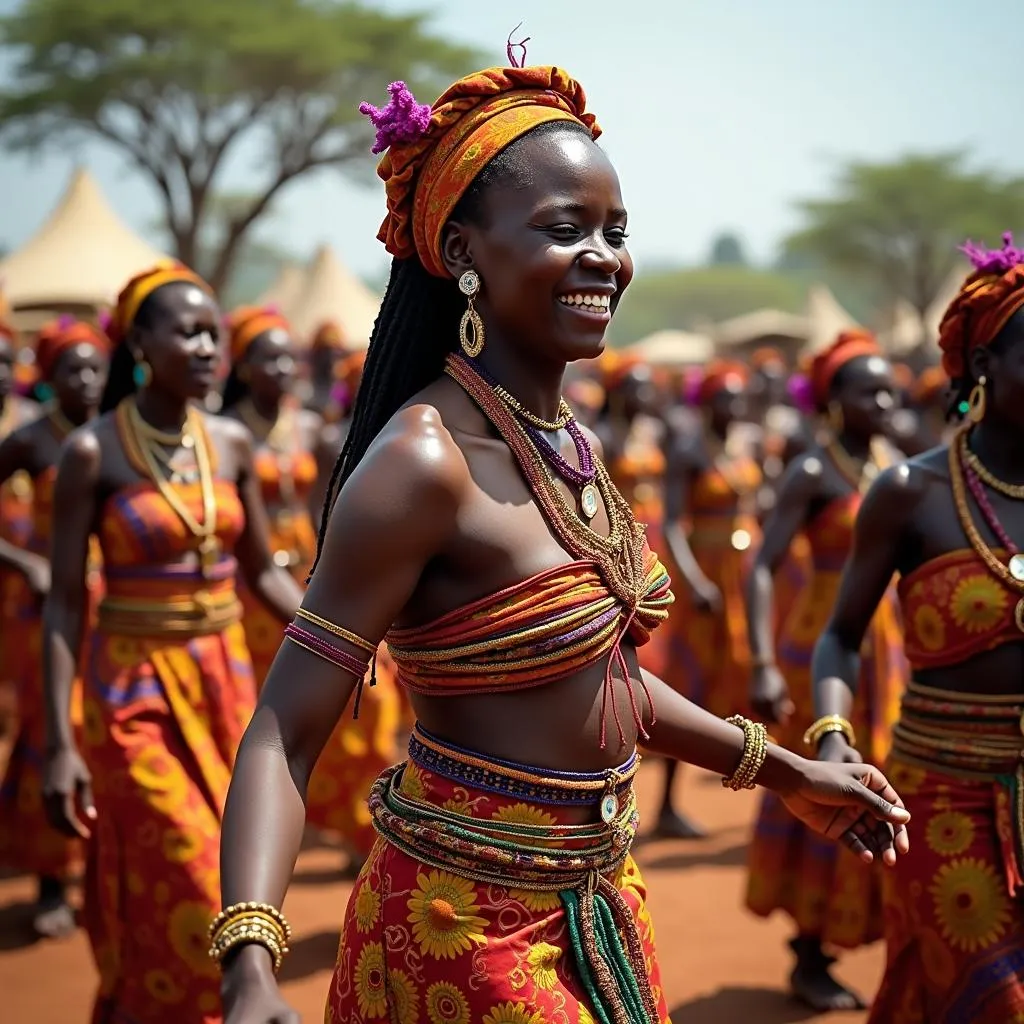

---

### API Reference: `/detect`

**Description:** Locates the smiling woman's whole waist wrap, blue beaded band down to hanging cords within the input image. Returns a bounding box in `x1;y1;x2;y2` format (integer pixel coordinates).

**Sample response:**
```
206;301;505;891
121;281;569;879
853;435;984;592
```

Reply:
370;726;658;1024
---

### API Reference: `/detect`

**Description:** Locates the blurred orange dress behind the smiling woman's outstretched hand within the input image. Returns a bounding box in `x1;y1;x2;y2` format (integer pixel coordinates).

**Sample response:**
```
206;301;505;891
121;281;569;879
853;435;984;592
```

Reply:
746;490;909;949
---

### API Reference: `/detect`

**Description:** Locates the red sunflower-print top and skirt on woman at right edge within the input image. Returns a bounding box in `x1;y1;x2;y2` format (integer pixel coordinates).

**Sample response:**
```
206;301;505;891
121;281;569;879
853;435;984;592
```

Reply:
869;549;1024;1024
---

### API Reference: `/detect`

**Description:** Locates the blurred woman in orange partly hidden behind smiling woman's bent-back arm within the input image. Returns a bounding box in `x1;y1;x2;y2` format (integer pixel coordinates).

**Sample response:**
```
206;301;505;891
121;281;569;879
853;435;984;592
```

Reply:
222;306;401;868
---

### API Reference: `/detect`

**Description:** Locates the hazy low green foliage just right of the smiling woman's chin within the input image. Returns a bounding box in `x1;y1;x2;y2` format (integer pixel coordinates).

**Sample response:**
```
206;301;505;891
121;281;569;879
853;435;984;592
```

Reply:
611;266;806;344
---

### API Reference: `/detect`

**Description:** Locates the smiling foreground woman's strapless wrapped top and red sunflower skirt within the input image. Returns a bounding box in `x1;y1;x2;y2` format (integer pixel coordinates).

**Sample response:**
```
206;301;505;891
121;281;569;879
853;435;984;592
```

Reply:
326;536;671;1024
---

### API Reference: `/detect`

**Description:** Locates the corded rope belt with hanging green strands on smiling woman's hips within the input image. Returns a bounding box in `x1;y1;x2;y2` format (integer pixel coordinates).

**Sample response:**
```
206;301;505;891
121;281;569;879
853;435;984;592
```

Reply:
370;728;658;1024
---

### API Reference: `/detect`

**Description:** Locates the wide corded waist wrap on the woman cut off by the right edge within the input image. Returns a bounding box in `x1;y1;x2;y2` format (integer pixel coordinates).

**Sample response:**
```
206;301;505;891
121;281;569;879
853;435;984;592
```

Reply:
893;681;1024;779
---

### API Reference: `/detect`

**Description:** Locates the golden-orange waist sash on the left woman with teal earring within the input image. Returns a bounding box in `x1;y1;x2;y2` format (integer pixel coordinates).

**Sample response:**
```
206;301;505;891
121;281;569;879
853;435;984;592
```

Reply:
97;557;242;636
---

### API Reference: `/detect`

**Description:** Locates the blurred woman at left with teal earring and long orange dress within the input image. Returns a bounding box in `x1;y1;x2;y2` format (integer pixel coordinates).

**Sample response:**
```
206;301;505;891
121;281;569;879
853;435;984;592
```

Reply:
40;262;300;1024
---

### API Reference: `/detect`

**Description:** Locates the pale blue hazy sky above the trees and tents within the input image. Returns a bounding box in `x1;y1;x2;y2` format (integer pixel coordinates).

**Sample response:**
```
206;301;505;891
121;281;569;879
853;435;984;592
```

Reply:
0;0;1024;274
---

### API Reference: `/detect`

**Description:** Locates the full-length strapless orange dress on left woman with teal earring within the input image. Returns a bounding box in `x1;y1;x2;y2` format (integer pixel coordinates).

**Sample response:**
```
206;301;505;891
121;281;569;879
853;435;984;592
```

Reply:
82;460;256;1024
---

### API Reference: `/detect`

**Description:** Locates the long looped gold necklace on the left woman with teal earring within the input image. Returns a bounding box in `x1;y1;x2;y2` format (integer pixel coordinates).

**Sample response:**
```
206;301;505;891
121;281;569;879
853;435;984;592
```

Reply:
118;397;221;578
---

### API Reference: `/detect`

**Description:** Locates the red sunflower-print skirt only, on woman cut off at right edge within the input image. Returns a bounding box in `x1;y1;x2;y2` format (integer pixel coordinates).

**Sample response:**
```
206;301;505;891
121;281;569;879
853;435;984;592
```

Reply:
869;700;1024;1024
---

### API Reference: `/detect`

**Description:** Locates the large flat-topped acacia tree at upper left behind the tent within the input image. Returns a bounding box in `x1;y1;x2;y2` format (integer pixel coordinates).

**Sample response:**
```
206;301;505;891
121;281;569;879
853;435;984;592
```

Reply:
0;0;476;288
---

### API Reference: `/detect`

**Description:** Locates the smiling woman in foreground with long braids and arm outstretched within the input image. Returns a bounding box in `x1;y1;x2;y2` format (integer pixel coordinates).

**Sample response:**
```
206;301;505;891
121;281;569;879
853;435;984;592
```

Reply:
213;68;906;1024
